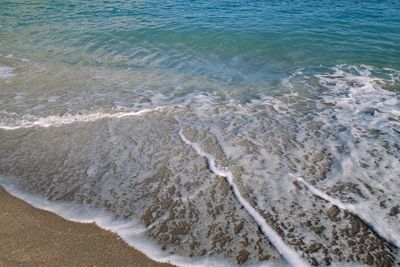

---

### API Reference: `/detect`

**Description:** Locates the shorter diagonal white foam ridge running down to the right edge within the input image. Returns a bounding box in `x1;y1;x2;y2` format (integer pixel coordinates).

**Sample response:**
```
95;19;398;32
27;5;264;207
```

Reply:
290;174;400;248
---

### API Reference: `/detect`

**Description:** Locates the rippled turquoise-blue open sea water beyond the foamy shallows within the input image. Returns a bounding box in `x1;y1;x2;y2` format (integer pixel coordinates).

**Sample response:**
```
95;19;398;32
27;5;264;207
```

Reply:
1;1;400;82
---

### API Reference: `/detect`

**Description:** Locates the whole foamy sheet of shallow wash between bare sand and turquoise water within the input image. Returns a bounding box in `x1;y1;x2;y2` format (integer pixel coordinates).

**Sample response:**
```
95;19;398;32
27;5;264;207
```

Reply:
0;65;400;266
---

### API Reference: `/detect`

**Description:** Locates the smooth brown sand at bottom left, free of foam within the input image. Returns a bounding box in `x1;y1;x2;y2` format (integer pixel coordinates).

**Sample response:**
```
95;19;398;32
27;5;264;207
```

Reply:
0;187;172;267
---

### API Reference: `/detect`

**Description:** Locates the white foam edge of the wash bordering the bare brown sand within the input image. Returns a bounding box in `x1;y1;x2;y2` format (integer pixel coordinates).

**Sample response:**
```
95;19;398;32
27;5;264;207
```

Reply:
0;178;268;267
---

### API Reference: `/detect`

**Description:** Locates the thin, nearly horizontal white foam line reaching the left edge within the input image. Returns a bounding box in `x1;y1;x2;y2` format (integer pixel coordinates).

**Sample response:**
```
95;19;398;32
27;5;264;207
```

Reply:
0;107;163;130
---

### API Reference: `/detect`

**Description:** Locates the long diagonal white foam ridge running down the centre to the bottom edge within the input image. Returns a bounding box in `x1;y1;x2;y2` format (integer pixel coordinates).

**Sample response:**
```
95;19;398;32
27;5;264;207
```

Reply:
179;129;309;267
